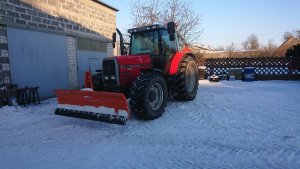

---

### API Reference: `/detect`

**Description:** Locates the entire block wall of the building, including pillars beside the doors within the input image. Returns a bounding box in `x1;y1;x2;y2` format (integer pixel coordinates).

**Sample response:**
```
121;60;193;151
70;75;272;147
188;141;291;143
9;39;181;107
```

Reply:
0;0;116;89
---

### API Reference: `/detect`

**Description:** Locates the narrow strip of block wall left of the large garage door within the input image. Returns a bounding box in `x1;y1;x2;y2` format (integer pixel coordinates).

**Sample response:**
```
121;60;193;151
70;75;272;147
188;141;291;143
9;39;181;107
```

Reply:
0;25;10;85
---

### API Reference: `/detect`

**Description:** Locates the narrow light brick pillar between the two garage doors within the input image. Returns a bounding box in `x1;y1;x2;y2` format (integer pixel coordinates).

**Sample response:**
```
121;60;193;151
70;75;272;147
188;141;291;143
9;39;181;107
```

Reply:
67;36;78;89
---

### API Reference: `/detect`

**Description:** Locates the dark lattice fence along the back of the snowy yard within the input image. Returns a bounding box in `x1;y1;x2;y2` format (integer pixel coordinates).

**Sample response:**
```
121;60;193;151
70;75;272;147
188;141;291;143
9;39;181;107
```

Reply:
198;57;300;80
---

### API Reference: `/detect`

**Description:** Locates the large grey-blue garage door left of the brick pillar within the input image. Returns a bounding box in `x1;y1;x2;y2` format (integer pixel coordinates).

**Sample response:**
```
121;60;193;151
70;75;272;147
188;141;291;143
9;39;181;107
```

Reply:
7;28;69;98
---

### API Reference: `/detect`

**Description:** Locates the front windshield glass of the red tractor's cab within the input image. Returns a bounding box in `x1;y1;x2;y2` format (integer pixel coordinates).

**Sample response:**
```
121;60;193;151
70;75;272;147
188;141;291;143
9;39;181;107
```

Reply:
130;31;159;55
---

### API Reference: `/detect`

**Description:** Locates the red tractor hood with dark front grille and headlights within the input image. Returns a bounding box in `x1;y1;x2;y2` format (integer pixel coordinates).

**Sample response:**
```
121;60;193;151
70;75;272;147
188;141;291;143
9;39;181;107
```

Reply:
102;55;151;87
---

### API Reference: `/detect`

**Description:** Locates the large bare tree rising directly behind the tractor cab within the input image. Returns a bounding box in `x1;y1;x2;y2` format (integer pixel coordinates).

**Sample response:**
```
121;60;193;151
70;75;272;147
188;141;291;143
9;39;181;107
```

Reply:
131;0;203;44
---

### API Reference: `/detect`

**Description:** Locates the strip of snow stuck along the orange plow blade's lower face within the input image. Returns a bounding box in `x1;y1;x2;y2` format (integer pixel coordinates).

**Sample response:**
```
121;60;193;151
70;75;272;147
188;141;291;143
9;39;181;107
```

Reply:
57;104;128;119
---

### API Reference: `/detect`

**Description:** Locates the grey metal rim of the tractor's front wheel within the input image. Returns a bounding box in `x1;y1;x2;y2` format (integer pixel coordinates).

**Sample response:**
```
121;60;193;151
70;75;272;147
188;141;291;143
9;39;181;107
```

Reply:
148;83;164;110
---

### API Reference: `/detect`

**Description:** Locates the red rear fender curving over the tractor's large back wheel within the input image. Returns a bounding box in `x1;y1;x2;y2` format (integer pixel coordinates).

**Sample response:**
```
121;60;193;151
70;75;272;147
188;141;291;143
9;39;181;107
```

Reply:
169;51;196;75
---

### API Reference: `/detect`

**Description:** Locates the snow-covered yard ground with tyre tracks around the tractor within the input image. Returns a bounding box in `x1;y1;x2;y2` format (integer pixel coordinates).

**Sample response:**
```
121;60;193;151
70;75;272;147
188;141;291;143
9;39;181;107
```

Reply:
0;81;300;169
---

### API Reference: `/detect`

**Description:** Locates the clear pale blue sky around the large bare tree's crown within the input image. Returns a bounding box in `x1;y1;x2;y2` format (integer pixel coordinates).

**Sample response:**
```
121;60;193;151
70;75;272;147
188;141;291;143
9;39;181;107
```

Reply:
103;0;300;48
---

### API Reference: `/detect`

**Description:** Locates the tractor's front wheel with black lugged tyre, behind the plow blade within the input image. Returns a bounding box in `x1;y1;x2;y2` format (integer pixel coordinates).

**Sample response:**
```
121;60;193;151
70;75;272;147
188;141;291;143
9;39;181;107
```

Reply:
129;73;168;120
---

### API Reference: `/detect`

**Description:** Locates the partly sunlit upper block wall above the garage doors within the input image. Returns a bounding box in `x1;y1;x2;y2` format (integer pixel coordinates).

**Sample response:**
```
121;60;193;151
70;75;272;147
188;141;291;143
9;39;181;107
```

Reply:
0;0;116;41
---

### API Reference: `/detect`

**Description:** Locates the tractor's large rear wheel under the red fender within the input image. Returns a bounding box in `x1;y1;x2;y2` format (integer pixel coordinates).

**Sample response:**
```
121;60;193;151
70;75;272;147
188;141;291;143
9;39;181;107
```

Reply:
173;56;198;101
